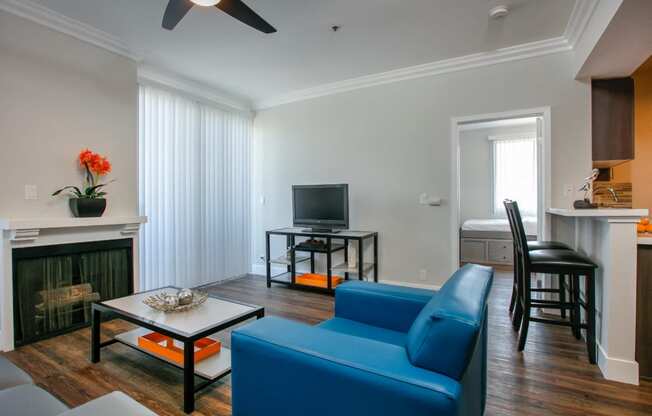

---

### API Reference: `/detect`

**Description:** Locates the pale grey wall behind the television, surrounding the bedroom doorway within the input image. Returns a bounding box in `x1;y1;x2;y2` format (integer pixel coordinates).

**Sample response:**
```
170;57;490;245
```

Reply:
253;53;591;285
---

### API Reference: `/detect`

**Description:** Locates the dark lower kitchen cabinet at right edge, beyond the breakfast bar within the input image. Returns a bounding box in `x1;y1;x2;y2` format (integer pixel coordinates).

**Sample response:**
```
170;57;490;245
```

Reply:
636;245;652;378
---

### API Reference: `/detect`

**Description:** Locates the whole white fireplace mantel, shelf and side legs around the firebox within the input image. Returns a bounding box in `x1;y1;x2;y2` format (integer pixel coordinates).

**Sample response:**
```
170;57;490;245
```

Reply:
0;216;147;351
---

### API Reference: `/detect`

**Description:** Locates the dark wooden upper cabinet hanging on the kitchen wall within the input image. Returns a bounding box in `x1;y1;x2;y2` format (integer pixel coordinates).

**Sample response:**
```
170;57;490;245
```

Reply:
591;78;634;167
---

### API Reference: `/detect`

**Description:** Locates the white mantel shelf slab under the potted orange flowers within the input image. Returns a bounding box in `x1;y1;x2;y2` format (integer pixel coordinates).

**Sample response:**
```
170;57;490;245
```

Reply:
0;216;147;230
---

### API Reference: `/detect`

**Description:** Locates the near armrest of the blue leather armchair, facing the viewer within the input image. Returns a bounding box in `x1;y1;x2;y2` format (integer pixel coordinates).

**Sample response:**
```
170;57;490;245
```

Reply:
231;317;462;416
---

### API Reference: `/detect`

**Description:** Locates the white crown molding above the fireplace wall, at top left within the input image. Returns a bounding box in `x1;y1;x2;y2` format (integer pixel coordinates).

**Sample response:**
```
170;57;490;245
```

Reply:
0;0;142;62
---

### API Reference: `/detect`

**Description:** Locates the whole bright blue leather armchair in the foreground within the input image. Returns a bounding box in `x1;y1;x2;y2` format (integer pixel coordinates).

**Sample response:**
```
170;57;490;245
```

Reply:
232;265;493;416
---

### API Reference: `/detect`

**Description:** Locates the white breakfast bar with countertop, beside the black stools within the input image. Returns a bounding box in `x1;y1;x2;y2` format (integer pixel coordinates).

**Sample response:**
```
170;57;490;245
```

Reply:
548;208;648;384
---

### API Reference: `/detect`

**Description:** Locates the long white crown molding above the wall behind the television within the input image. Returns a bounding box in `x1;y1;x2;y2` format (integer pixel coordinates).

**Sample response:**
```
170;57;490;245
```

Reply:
254;36;572;110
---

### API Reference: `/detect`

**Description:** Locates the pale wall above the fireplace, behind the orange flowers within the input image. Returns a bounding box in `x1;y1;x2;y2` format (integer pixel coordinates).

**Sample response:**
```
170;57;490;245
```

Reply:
0;12;138;218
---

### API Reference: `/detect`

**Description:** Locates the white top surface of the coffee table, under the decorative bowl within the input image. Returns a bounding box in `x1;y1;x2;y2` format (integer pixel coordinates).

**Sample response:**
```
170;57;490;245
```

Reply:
101;288;258;337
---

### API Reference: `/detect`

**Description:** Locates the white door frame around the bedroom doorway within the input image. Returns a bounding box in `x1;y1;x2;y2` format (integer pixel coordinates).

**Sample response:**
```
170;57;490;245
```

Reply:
450;107;552;272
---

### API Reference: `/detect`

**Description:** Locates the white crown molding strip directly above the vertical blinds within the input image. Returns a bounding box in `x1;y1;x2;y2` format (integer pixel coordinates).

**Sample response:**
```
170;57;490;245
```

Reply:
138;65;252;115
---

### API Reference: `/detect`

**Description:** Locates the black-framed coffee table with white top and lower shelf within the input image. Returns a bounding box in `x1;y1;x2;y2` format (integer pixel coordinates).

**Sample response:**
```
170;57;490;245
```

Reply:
90;287;265;413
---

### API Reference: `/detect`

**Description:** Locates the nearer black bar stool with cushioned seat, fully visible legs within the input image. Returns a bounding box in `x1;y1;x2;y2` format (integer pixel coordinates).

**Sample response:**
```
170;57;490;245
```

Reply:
504;200;598;364
